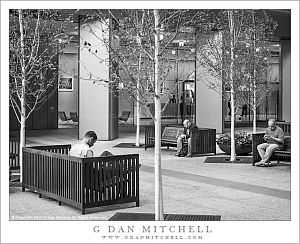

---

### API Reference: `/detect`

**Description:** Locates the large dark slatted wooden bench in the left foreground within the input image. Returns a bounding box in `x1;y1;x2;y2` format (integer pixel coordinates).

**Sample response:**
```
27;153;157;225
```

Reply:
22;145;139;214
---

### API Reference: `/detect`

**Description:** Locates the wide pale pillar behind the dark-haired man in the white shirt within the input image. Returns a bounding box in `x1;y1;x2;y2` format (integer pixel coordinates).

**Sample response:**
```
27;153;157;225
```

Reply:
78;19;118;140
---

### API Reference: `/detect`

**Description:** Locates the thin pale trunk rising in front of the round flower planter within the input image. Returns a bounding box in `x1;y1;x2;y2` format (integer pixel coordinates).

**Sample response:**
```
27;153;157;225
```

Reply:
228;10;236;161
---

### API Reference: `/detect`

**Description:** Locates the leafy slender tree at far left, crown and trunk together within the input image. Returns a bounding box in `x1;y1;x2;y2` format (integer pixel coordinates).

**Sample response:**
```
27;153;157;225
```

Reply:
9;9;68;177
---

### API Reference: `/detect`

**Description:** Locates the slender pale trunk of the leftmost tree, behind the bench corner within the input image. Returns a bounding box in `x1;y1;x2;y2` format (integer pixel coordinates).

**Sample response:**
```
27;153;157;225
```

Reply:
18;9;26;181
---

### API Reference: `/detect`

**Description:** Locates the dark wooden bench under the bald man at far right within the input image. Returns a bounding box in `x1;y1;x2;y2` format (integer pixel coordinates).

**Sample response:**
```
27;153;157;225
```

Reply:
252;133;291;165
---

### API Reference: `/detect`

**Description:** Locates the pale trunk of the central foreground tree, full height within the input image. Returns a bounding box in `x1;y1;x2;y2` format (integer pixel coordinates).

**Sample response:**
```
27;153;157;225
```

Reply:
154;10;164;220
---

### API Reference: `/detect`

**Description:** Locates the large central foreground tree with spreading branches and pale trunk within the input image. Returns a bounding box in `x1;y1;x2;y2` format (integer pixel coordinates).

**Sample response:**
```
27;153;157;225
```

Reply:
82;9;204;220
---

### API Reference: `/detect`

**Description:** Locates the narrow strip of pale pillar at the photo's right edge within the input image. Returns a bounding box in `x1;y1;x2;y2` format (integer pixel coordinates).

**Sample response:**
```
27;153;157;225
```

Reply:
281;40;291;122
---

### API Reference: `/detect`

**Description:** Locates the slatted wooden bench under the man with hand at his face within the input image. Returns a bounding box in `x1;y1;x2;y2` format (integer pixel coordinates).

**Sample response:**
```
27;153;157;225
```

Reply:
145;125;216;155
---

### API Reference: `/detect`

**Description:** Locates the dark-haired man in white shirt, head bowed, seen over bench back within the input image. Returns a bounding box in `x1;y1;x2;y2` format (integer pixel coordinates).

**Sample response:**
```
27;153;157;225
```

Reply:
69;131;97;158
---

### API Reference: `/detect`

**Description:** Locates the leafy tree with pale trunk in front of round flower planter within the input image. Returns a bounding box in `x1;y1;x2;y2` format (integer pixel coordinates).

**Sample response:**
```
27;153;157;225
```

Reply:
197;10;271;161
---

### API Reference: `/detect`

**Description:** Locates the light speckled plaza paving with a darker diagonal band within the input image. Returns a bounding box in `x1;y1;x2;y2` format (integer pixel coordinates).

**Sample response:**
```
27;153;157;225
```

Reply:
9;126;291;221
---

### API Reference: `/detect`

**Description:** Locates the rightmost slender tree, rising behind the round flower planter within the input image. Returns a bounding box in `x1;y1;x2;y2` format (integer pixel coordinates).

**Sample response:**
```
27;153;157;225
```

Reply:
240;10;277;133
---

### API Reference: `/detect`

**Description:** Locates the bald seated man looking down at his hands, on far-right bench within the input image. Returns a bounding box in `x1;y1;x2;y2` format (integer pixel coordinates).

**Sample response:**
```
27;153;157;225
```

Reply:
255;119;284;166
